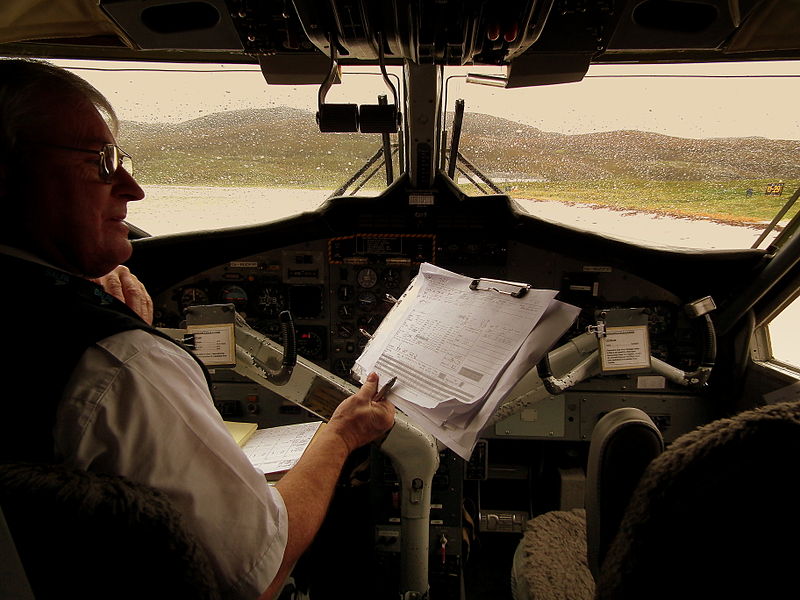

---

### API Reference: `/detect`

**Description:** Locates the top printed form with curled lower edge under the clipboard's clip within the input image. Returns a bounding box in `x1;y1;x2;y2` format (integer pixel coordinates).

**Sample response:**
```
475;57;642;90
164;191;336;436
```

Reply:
352;263;544;414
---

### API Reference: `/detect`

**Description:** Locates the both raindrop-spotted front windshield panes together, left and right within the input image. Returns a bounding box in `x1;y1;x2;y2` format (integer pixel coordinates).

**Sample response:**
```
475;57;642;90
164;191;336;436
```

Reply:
53;61;800;248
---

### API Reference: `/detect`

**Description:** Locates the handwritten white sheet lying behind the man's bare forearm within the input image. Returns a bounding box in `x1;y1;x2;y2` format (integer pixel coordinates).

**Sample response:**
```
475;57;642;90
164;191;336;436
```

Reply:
242;421;321;475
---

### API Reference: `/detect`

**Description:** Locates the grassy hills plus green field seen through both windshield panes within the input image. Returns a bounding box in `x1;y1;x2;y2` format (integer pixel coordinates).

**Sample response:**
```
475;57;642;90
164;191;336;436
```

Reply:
119;107;800;220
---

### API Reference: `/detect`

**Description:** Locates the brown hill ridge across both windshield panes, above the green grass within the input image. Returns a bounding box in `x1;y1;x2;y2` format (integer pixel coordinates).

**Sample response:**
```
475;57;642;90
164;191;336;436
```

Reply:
119;106;800;186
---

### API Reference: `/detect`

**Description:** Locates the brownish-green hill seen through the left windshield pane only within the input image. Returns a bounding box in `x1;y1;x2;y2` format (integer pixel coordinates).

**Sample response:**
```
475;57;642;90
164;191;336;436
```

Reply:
119;107;380;188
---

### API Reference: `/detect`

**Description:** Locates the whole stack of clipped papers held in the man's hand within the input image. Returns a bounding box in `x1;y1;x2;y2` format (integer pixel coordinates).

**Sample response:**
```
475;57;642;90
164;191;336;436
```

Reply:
353;263;580;460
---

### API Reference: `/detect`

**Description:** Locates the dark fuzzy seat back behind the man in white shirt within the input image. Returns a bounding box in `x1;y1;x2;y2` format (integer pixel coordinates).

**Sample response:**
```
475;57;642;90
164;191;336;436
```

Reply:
0;464;219;600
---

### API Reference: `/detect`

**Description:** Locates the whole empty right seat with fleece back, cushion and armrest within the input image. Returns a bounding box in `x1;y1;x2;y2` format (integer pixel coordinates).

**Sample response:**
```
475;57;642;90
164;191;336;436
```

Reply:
512;402;800;600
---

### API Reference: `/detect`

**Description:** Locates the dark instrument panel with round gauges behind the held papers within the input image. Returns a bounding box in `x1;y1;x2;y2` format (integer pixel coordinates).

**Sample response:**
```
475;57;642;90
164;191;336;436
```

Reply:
155;232;705;440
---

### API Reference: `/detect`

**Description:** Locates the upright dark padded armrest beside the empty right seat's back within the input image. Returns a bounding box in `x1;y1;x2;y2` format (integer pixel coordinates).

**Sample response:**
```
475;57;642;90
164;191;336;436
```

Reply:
586;407;664;581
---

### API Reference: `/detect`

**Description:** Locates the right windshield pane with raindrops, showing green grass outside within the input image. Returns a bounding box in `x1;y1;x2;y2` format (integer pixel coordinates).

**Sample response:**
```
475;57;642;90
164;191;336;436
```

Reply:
448;62;800;253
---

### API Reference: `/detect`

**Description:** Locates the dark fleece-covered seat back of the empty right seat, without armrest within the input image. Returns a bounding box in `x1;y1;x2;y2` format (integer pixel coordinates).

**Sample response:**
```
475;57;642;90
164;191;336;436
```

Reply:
596;402;800;600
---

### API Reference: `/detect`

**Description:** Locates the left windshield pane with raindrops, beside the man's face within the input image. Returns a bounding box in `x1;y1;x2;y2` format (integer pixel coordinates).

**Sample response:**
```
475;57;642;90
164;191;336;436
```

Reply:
53;61;400;235
